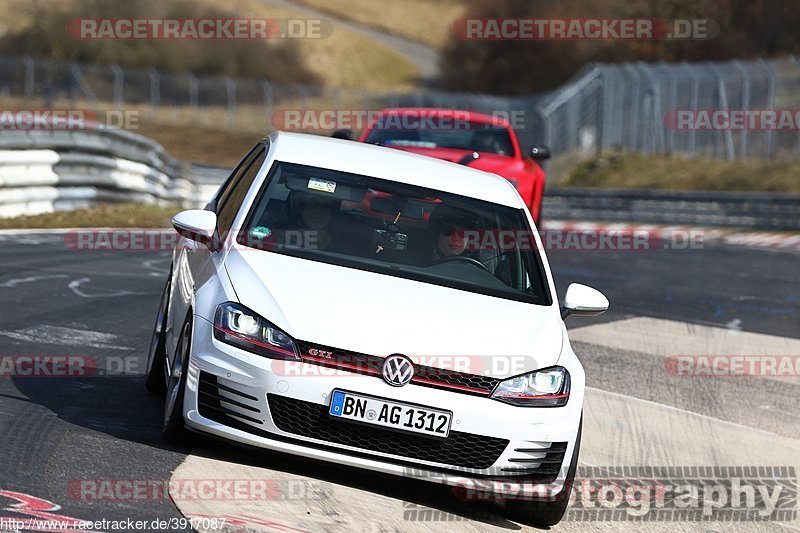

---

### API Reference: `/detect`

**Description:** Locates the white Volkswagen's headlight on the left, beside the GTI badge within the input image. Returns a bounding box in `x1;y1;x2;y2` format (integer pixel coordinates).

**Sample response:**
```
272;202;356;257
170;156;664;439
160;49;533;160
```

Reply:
214;302;300;360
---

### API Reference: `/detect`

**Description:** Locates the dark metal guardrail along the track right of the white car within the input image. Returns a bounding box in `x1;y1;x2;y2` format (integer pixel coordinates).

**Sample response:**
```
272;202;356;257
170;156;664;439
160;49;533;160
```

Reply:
542;188;800;231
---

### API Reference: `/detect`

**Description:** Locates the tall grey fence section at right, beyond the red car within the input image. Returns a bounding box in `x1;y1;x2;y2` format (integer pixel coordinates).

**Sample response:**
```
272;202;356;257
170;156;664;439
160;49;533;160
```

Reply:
541;58;800;159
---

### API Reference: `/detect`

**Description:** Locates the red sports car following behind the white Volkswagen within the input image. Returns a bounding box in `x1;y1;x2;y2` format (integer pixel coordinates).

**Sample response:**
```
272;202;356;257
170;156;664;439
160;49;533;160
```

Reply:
334;107;550;224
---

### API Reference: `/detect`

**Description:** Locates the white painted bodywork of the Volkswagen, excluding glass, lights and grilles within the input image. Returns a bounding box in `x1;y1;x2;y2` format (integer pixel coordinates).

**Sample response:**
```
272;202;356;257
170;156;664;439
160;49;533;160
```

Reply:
166;133;585;496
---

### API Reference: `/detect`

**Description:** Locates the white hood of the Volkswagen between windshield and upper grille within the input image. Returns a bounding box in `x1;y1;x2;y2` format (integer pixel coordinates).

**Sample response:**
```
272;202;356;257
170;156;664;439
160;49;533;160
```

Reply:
226;248;563;378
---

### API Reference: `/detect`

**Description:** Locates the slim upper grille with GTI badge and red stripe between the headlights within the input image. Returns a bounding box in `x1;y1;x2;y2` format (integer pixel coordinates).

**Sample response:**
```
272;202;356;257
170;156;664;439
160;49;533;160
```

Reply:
297;341;500;396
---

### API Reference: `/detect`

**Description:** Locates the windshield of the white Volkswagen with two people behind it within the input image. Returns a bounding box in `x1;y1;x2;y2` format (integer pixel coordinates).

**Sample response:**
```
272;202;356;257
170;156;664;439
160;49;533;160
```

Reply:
238;162;550;305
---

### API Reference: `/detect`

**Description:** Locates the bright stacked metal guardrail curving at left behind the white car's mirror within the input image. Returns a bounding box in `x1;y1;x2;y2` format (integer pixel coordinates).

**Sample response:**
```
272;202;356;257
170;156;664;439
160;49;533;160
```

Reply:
0;129;218;216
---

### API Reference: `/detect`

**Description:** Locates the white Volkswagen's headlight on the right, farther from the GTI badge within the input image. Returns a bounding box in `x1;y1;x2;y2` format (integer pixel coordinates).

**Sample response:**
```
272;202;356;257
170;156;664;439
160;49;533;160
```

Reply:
491;366;569;407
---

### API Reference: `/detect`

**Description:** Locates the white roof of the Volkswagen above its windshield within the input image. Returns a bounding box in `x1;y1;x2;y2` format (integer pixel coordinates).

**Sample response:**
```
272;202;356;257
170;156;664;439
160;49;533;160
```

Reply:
269;131;523;208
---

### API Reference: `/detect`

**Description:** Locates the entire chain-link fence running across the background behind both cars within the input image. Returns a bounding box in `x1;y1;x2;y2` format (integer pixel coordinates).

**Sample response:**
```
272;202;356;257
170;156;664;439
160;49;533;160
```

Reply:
0;57;800;164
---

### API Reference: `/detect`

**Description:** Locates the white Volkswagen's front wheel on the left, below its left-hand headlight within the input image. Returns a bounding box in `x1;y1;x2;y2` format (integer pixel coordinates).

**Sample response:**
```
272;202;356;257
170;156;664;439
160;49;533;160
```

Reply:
162;317;192;444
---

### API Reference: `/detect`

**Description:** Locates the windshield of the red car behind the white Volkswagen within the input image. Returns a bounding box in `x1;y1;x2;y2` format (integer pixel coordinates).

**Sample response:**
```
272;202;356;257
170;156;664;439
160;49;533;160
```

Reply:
366;122;514;156
